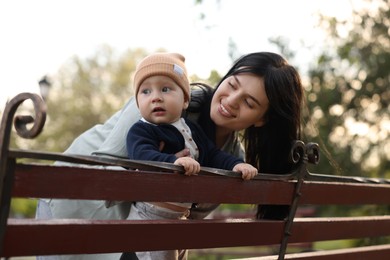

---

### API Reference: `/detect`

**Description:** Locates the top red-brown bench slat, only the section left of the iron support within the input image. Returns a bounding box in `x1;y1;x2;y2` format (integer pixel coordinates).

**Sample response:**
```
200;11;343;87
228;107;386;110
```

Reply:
13;164;294;204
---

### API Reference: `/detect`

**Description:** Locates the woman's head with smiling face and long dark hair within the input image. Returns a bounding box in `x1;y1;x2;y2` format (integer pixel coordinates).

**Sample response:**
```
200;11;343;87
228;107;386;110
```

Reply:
191;52;304;219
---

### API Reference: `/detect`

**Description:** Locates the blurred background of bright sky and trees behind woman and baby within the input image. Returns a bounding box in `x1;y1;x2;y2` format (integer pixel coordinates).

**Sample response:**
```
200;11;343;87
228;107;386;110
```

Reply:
0;0;390;257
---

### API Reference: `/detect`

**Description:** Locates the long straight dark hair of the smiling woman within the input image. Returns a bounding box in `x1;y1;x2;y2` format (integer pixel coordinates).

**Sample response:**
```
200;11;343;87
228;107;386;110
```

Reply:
189;52;304;219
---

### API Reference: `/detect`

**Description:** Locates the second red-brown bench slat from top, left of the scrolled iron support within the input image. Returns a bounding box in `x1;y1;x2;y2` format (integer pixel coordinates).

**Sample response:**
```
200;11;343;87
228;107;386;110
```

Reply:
4;219;284;256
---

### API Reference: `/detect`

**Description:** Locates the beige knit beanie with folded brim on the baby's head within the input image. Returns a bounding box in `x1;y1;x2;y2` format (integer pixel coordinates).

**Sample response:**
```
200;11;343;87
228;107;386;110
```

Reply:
134;53;190;101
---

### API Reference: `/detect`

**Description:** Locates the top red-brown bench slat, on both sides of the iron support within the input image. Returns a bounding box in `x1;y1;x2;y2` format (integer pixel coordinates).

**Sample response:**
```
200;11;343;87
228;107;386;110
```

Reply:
13;164;390;205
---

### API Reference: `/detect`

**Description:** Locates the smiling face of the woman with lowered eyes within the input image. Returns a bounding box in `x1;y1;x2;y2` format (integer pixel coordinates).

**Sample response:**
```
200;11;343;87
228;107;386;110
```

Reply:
210;73;269;131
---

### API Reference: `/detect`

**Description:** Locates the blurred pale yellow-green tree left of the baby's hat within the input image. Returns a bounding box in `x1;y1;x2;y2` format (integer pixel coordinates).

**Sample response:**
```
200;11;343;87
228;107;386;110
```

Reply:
21;46;146;152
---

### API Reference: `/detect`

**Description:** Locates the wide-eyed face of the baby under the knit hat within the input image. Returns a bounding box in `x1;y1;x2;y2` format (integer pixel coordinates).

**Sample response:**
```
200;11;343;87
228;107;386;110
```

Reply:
137;76;188;124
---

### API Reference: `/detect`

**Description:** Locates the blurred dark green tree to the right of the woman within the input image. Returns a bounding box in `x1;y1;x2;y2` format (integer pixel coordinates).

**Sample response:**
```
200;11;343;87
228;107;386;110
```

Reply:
306;0;390;177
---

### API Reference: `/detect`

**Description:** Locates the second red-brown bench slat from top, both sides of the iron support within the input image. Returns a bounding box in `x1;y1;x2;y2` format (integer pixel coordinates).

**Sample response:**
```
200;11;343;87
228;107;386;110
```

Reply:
4;216;390;256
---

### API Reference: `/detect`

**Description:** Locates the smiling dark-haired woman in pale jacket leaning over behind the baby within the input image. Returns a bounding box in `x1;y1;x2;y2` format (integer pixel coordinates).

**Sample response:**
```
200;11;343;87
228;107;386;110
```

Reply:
37;52;303;259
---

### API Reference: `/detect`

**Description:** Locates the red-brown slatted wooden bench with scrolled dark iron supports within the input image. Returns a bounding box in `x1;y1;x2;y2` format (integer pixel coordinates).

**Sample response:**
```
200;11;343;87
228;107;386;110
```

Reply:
0;93;390;260
